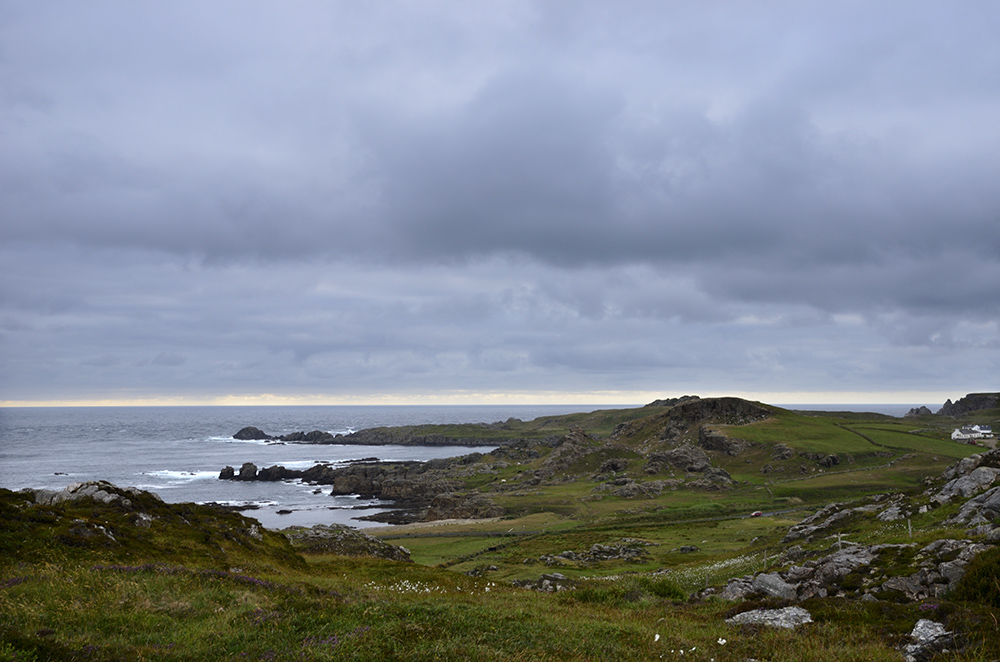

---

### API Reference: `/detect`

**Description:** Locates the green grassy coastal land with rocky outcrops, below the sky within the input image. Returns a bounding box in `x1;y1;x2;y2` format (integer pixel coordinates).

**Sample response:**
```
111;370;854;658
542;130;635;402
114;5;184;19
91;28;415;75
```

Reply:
0;397;1000;662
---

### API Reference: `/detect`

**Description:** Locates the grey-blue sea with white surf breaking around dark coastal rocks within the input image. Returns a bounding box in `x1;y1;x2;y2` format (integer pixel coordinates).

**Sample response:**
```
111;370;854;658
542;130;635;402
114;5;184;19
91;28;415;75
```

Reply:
0;405;909;529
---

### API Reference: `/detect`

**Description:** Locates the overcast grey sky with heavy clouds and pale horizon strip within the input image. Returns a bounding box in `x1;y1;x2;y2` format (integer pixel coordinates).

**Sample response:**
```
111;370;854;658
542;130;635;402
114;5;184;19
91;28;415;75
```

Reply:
0;0;1000;408
